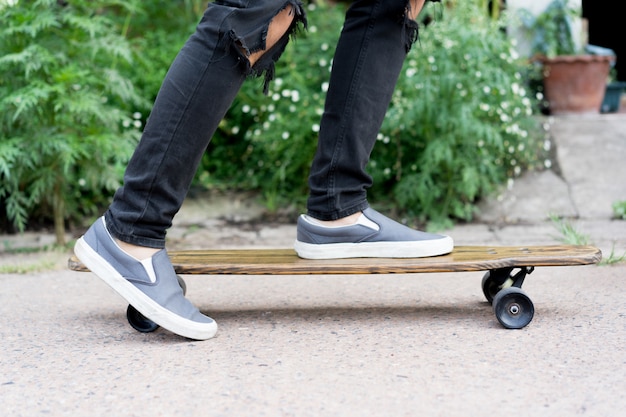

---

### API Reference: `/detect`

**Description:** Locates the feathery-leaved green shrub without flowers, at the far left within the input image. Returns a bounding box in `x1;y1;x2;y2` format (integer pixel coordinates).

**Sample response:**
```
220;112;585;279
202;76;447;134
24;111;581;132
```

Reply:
0;0;142;244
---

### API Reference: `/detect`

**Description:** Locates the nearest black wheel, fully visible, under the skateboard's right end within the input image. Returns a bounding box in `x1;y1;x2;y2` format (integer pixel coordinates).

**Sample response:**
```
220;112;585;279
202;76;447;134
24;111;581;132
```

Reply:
493;287;535;329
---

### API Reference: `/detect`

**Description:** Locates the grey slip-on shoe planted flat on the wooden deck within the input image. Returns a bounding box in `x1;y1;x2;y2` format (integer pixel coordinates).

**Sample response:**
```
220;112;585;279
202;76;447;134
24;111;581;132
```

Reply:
294;208;454;259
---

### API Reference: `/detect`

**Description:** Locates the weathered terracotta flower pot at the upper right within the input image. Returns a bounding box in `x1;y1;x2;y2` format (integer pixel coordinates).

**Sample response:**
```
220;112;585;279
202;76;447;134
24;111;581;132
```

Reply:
539;55;615;114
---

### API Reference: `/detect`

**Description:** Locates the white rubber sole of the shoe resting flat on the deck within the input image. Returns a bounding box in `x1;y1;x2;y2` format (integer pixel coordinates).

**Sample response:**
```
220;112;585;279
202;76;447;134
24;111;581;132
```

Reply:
294;236;454;259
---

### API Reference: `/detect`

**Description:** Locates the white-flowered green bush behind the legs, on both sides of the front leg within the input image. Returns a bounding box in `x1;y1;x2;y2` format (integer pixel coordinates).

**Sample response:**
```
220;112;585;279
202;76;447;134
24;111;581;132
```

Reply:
198;2;542;227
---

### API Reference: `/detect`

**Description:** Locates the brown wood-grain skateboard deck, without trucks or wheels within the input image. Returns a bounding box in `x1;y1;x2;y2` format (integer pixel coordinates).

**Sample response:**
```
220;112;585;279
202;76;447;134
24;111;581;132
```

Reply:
68;245;602;275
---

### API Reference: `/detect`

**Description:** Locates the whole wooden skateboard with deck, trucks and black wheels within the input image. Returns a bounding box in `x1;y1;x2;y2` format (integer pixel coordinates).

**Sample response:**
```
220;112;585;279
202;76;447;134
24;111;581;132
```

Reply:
69;245;602;333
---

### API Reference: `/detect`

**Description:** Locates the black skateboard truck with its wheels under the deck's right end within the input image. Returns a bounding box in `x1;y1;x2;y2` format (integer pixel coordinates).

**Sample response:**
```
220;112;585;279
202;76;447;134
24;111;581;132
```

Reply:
482;266;535;329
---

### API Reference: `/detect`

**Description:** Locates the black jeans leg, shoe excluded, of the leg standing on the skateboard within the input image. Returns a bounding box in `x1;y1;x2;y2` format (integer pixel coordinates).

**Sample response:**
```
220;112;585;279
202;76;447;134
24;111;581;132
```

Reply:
308;0;421;220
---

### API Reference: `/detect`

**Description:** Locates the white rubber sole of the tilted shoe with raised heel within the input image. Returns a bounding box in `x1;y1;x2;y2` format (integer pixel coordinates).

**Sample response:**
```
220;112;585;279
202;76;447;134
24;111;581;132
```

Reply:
74;237;217;340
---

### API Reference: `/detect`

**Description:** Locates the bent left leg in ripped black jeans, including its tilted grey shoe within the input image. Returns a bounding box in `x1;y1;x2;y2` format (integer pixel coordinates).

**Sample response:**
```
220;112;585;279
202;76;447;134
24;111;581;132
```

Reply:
74;0;304;340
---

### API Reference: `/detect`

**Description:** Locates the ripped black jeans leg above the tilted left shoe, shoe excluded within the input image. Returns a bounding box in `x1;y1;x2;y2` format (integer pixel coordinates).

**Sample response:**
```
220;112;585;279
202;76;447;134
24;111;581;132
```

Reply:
105;0;303;249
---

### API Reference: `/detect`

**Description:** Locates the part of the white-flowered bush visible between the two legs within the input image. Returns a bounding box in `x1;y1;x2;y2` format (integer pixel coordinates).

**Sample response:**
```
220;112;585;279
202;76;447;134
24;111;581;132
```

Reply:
198;2;345;209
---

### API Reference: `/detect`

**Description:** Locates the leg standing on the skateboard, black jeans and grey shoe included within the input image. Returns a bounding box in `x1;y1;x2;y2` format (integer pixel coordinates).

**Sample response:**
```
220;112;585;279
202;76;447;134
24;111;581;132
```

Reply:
296;0;453;258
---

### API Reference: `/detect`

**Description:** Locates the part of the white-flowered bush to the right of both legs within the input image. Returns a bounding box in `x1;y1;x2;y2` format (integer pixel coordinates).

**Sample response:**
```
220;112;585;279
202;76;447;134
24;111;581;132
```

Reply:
371;2;543;226
